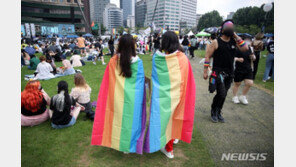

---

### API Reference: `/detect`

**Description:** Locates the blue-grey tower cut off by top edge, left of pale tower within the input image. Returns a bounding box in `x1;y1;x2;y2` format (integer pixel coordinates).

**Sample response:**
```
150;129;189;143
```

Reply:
89;0;110;24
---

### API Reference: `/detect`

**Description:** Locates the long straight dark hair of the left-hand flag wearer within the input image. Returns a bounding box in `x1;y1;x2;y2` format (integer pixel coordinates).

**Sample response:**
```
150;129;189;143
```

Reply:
117;34;136;78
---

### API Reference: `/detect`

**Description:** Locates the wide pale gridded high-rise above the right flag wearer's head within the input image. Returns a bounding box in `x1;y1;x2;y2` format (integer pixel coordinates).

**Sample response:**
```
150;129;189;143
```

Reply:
145;0;196;30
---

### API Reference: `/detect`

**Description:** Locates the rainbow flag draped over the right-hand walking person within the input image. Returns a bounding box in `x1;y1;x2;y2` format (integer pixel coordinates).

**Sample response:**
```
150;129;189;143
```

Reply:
144;51;195;153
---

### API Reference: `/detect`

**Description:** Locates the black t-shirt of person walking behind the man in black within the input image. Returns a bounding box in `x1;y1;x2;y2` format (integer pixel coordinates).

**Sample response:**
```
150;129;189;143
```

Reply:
235;47;252;72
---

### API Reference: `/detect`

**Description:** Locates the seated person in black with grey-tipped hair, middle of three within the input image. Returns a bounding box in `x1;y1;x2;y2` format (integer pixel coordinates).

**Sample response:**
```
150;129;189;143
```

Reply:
50;81;85;129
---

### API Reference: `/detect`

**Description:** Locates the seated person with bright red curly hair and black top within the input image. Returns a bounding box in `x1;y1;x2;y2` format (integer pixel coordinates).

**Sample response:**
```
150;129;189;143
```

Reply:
21;81;50;126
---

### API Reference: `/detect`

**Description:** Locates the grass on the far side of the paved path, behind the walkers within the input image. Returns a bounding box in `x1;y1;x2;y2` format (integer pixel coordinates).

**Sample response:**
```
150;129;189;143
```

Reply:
195;50;274;94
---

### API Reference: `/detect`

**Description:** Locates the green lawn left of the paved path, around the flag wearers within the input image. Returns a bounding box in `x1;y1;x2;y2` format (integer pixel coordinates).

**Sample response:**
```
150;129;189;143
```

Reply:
21;50;214;167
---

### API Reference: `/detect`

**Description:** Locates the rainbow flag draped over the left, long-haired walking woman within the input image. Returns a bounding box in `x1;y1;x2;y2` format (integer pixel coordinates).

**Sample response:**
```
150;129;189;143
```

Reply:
91;55;146;154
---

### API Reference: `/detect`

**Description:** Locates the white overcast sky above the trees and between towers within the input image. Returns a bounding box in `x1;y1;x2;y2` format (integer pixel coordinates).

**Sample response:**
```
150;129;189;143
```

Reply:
111;0;274;18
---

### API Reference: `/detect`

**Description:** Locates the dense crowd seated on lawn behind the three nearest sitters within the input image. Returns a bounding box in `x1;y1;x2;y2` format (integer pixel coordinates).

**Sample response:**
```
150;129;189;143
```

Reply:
21;37;114;80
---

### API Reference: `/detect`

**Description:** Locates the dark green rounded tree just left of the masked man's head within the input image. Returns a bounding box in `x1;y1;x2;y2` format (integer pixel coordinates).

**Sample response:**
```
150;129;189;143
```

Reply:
197;10;223;31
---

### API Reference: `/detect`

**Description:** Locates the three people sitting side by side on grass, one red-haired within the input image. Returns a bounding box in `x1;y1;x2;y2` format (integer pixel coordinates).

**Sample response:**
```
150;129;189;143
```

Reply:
21;73;94;129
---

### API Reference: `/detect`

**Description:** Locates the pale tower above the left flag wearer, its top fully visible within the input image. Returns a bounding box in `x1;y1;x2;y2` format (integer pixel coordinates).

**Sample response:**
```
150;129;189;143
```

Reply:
103;3;123;32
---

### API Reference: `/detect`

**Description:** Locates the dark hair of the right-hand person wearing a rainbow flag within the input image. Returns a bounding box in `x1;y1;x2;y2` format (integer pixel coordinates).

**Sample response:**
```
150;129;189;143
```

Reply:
160;31;184;54
